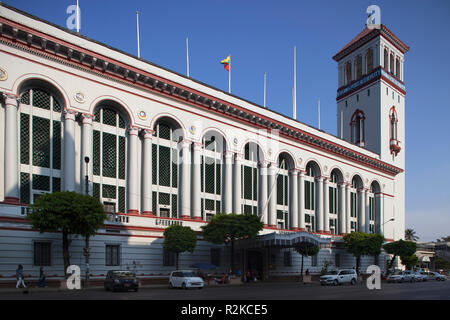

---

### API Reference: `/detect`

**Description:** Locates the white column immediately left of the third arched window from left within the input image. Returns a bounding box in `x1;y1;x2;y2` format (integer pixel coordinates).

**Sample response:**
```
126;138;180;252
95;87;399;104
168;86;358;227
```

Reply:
142;130;155;215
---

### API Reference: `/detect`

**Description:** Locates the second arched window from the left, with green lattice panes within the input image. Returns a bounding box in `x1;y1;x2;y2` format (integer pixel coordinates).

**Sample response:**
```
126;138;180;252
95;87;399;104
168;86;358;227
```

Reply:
92;105;127;212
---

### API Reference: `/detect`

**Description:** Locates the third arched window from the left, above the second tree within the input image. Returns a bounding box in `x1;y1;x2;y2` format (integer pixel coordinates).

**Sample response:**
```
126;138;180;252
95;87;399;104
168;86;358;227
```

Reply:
152;119;180;218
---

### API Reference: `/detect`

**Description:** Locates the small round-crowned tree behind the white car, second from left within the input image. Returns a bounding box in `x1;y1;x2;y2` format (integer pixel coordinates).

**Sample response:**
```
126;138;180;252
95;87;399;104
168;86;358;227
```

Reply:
163;225;197;270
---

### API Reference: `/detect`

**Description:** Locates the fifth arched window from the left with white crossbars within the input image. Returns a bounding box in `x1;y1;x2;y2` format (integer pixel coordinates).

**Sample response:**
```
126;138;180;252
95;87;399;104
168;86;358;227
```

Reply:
241;142;262;214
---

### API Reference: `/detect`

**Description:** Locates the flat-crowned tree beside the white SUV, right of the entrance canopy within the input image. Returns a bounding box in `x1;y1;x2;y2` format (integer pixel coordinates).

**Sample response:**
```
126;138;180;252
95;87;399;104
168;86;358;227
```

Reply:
344;231;384;272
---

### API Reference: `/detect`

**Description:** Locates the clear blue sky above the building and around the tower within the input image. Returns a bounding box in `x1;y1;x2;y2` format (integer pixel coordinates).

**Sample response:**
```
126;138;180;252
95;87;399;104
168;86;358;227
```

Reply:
4;0;450;241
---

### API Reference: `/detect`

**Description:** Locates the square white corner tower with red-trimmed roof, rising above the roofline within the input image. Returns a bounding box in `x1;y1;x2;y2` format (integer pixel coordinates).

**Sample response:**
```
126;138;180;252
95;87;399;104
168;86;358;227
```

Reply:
333;25;409;168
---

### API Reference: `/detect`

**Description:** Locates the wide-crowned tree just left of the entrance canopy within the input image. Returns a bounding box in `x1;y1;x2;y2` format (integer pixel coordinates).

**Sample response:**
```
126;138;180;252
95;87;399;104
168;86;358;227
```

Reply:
202;213;264;271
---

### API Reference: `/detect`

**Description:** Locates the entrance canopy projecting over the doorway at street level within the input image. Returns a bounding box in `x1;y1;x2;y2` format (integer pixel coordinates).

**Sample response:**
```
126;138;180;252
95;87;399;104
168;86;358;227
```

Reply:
236;231;331;249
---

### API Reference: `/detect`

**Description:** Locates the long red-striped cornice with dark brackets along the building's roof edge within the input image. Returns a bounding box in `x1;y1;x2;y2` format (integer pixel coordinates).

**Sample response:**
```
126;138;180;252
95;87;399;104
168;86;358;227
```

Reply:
0;17;403;176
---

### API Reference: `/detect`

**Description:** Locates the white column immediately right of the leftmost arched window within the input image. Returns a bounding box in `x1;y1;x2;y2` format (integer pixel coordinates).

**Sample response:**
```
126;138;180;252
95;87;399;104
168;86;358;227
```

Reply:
64;110;77;191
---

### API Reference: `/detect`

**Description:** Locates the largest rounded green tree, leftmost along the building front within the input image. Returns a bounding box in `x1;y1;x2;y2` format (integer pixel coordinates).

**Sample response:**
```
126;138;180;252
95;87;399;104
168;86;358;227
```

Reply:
28;191;106;276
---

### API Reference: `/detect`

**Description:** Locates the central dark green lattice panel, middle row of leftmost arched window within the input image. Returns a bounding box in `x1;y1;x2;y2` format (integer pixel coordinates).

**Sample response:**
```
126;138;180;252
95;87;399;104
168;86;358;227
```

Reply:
33;116;50;168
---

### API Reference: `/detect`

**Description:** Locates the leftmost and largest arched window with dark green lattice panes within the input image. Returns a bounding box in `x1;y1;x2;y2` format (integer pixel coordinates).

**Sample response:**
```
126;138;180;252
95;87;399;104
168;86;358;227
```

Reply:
19;85;64;204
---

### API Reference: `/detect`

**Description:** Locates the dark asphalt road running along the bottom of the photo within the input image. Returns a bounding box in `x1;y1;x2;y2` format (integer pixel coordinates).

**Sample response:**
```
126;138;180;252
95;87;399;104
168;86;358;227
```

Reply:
0;281;450;301
